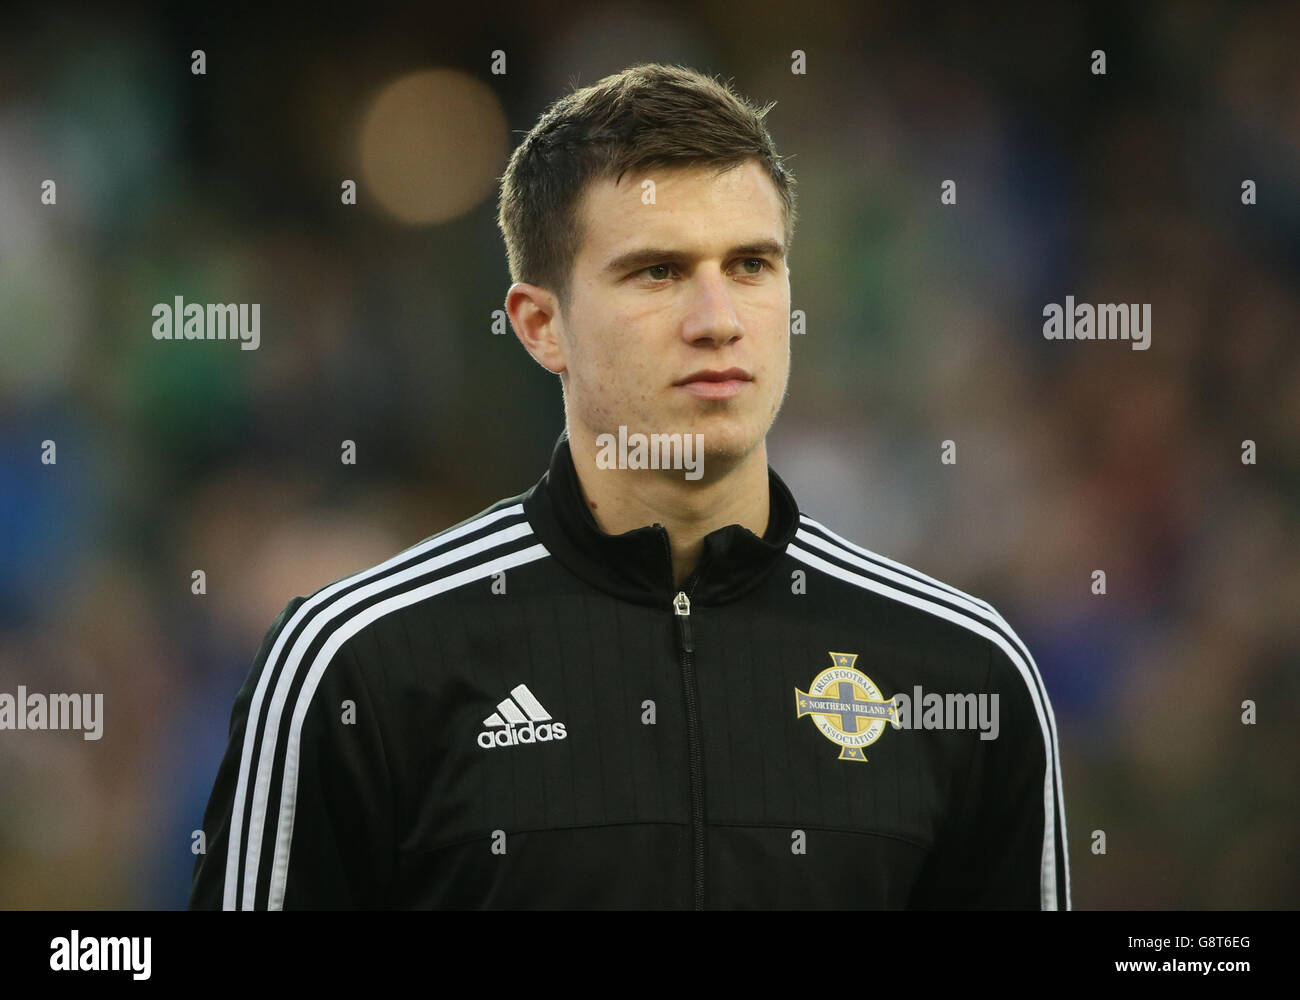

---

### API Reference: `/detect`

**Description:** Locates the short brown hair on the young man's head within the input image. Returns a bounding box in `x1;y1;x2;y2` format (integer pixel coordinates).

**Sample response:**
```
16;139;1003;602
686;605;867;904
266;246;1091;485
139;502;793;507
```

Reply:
497;62;797;307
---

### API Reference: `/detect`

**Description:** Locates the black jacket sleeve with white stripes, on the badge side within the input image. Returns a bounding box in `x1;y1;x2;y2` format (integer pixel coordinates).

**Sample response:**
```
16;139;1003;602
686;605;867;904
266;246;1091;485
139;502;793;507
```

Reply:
914;634;1070;910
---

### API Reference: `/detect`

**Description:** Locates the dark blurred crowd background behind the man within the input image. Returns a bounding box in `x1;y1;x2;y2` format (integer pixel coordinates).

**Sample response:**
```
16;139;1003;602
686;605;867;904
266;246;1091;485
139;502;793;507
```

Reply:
0;0;1300;909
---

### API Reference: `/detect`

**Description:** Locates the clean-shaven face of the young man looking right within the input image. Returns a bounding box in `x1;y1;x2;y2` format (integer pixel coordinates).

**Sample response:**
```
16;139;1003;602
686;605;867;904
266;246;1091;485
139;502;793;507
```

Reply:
558;160;790;475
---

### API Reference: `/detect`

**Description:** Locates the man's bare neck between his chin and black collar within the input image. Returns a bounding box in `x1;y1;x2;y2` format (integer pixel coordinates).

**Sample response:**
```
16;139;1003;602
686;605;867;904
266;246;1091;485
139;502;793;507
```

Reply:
569;428;770;586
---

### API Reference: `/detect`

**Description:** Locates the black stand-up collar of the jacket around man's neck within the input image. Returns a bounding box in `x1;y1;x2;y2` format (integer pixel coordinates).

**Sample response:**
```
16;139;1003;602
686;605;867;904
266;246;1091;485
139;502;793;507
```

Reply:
524;433;800;609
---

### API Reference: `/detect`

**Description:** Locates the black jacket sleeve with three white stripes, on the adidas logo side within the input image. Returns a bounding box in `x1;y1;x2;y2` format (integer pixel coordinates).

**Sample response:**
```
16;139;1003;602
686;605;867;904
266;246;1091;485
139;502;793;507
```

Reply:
189;597;395;910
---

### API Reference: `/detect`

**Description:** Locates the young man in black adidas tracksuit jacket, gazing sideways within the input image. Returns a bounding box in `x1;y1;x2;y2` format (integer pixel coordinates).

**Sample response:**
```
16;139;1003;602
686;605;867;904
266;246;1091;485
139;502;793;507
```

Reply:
191;58;1069;909
